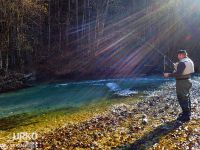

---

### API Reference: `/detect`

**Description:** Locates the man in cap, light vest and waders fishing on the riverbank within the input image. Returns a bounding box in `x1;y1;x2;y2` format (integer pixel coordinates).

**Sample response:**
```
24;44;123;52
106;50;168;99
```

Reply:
164;50;194;122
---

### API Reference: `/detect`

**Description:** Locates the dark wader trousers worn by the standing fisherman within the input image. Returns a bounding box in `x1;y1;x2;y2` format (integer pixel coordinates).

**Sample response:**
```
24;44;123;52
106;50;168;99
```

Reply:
176;79;192;116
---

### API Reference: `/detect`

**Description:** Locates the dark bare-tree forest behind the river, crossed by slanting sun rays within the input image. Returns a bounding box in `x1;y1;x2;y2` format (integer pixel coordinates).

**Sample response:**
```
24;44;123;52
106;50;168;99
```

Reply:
0;0;200;90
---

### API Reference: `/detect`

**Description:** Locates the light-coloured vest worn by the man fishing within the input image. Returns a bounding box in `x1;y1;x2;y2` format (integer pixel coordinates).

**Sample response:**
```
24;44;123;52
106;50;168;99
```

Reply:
179;57;194;75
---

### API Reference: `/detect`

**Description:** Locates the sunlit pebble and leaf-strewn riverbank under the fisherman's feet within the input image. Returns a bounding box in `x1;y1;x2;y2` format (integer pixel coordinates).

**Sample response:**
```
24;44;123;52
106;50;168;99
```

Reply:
1;77;200;150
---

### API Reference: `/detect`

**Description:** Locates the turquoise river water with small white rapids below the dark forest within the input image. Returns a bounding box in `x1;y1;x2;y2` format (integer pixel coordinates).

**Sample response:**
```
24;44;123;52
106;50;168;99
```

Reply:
0;76;171;118
